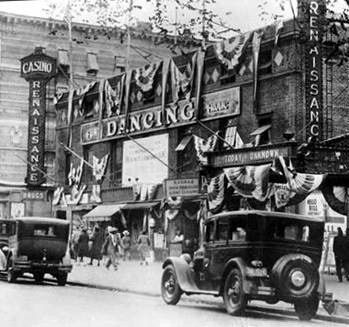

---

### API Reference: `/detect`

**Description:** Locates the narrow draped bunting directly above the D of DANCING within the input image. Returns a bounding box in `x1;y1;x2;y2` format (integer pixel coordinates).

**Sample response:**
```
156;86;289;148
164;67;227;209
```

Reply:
104;74;125;117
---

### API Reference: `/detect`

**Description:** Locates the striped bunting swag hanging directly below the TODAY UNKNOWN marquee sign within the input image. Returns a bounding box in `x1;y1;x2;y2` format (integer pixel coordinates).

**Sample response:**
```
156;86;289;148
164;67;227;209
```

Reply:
224;164;272;202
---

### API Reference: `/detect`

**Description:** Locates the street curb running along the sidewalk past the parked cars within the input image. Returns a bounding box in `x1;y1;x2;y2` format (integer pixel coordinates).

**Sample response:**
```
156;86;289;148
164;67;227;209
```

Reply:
65;279;349;324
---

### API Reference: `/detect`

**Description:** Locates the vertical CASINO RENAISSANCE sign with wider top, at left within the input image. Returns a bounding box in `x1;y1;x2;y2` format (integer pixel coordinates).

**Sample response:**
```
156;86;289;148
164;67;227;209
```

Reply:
21;47;56;186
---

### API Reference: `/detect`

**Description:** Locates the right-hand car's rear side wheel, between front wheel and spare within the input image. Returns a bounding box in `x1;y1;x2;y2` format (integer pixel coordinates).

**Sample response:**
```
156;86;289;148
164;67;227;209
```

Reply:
223;268;247;316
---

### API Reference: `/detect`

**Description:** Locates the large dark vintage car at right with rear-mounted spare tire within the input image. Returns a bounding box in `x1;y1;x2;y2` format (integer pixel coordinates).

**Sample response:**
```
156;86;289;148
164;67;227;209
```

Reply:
161;211;331;320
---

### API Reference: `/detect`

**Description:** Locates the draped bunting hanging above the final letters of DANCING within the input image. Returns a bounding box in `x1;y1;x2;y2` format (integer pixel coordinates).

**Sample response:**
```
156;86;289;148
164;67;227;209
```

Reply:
170;51;198;102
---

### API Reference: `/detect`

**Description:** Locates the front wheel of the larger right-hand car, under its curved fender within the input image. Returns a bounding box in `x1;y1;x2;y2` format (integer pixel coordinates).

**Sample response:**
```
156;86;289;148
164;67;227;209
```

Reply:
161;265;182;305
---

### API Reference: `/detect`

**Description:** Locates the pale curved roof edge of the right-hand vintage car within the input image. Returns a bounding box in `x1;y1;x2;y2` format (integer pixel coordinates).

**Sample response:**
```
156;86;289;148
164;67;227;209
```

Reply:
206;210;325;223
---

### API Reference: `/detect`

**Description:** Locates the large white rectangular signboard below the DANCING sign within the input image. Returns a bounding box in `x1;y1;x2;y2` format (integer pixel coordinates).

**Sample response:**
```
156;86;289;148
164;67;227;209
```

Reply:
122;134;168;186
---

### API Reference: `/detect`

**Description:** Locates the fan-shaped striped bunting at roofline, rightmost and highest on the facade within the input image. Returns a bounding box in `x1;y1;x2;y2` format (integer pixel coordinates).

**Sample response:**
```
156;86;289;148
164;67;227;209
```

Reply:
214;32;251;70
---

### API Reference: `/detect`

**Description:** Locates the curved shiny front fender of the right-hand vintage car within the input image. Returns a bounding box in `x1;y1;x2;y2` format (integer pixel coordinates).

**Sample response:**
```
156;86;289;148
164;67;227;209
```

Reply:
162;257;200;293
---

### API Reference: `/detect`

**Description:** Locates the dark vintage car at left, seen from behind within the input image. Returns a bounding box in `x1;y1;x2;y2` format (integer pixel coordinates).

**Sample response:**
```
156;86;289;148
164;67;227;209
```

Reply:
2;217;72;286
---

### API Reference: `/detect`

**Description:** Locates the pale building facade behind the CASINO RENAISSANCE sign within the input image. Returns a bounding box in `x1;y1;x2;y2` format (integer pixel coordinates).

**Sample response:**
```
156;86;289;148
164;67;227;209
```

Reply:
0;13;179;217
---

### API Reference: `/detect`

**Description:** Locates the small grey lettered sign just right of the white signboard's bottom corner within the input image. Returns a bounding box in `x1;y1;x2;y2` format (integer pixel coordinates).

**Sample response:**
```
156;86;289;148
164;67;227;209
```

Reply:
165;178;199;197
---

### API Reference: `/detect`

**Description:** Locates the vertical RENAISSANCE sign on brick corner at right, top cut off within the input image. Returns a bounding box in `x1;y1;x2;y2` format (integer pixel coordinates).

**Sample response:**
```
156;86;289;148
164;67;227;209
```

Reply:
299;0;326;140
